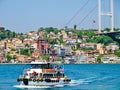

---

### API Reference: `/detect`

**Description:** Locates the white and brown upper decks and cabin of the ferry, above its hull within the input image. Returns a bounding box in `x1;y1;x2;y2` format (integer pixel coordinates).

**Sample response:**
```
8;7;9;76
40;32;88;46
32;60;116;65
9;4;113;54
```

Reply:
24;62;64;78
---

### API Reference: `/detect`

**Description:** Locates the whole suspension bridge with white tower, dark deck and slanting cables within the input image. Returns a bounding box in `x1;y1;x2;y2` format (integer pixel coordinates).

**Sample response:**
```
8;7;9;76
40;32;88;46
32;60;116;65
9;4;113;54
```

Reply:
66;0;120;44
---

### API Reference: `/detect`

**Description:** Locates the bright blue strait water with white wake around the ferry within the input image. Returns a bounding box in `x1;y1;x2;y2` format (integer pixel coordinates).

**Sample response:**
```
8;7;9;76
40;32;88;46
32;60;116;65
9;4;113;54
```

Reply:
0;64;120;90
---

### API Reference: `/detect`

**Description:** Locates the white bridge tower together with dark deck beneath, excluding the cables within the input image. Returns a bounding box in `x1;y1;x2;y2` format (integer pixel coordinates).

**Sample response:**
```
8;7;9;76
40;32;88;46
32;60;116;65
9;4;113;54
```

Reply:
97;0;120;44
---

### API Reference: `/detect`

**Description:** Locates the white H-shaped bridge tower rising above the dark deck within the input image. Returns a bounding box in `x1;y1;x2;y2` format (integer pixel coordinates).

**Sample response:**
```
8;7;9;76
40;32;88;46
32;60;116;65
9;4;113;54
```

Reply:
98;0;114;33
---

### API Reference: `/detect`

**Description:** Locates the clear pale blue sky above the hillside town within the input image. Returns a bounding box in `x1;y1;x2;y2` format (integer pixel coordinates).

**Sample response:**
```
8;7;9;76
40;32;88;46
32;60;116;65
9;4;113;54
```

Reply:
0;0;120;33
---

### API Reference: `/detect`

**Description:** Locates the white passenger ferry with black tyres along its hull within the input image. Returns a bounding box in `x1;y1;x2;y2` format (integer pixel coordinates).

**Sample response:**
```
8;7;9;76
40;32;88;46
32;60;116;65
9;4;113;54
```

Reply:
15;61;71;88
